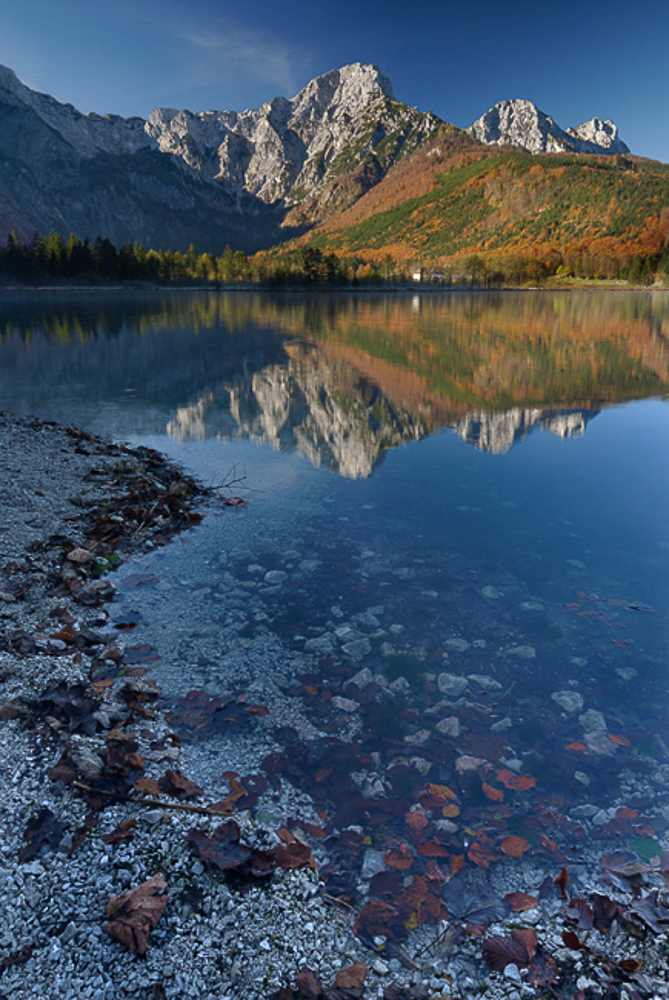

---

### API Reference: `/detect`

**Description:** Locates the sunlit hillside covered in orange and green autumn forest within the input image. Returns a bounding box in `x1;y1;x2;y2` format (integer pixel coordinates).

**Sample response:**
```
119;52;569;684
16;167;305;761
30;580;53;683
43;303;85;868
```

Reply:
290;135;669;282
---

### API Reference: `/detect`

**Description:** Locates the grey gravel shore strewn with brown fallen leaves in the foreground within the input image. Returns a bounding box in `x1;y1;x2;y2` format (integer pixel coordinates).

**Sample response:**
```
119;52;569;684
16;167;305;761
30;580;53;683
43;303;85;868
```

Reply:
0;414;669;1000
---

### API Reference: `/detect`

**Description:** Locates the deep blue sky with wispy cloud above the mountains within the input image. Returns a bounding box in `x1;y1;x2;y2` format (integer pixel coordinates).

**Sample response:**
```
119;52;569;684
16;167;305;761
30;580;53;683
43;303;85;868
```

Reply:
0;0;669;162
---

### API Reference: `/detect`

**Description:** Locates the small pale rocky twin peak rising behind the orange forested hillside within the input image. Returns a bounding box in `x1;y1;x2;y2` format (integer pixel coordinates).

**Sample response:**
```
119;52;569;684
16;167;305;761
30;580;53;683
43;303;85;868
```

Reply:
467;100;630;156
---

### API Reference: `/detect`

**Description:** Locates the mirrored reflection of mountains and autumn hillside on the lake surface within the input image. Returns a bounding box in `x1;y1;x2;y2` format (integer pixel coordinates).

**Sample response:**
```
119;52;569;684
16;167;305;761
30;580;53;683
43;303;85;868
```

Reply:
0;292;669;478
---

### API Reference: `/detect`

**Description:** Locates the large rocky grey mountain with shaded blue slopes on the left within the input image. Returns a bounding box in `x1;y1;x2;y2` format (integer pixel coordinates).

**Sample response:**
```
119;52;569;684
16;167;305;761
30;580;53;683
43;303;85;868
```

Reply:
0;63;440;252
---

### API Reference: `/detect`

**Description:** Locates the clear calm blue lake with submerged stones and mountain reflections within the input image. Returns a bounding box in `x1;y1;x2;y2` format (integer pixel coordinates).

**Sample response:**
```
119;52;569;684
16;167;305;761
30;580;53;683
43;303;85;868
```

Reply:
0;291;669;922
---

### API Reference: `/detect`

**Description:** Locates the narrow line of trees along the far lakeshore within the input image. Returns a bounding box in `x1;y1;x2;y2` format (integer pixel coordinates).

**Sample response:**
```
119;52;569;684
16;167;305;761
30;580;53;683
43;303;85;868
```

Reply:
0;232;669;288
